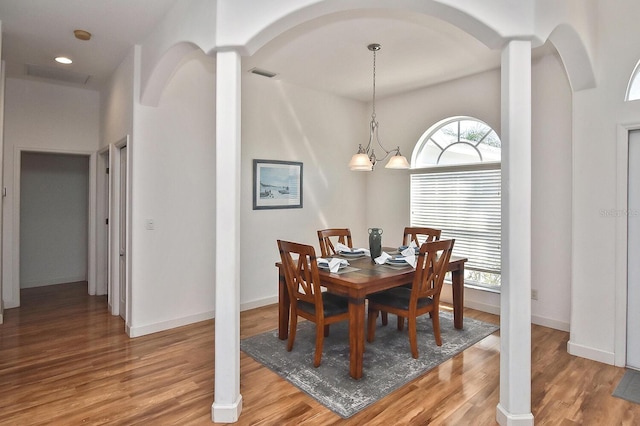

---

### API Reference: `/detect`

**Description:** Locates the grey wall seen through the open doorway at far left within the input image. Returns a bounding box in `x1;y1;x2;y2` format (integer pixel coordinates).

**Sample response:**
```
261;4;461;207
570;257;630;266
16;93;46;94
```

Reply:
20;153;89;288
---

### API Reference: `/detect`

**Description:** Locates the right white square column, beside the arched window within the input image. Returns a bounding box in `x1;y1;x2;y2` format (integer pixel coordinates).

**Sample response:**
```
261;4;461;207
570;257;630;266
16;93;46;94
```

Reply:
496;40;533;426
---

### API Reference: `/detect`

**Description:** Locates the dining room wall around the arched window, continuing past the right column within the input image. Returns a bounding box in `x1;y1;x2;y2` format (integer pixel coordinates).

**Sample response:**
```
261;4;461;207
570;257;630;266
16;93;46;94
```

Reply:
366;50;571;330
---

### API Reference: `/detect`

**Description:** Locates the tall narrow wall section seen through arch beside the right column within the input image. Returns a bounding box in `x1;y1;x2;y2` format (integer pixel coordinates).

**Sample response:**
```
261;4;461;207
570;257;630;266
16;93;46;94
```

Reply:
531;49;572;331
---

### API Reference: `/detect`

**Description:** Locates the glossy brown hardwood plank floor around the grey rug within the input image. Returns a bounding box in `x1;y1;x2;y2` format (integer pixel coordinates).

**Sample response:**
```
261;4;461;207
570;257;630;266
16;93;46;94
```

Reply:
0;283;640;425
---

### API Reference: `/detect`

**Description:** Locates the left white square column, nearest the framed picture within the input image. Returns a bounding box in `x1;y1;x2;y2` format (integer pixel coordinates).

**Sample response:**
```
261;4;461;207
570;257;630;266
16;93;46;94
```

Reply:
211;51;242;423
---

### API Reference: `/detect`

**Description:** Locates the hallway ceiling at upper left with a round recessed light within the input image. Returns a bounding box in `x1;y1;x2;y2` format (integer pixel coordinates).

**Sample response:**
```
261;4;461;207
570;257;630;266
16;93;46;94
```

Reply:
0;0;176;89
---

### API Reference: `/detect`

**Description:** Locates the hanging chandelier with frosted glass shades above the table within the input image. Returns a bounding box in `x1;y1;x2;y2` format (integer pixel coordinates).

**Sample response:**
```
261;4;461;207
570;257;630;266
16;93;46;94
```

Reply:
349;43;409;172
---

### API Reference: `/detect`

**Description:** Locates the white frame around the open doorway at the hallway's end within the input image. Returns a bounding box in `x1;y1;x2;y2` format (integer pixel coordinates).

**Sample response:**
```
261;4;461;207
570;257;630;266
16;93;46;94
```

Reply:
11;147;97;306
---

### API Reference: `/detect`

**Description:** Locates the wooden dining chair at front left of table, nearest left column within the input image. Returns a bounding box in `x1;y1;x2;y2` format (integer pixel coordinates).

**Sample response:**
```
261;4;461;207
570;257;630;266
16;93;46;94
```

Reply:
278;240;349;367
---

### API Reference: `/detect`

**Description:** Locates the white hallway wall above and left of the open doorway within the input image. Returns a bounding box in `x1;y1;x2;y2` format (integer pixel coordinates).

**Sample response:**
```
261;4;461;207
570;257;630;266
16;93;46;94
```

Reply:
2;78;99;308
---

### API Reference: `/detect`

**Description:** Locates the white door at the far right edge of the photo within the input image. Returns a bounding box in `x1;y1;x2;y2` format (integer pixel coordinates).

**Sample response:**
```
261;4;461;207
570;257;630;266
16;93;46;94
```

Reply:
627;130;640;370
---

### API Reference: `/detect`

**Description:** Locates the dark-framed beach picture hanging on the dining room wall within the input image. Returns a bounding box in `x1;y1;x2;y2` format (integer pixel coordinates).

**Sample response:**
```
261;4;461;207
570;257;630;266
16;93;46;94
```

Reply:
253;160;302;210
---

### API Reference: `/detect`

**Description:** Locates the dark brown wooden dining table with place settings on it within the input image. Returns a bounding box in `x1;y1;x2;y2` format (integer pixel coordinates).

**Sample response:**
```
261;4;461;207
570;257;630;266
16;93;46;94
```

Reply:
276;248;467;379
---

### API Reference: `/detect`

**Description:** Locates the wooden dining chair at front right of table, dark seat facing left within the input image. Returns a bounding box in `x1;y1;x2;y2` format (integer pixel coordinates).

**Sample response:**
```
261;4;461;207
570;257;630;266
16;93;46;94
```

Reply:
367;240;455;358
